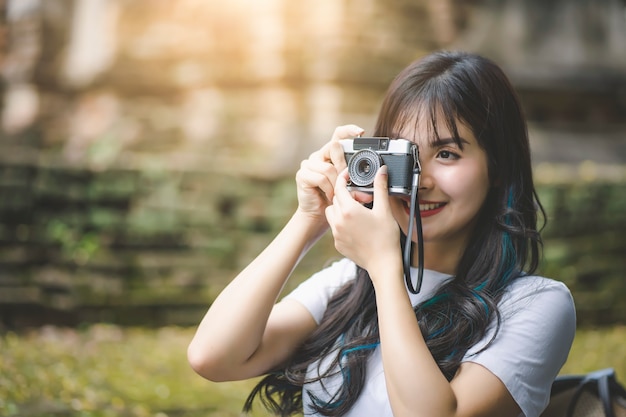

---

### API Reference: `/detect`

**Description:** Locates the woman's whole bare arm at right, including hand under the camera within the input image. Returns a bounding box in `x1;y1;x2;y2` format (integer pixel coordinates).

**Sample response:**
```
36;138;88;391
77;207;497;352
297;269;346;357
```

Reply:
326;167;520;417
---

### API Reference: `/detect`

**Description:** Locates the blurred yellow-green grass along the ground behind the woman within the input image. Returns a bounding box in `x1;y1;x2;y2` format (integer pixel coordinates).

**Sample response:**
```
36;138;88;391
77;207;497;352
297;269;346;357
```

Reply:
0;324;626;417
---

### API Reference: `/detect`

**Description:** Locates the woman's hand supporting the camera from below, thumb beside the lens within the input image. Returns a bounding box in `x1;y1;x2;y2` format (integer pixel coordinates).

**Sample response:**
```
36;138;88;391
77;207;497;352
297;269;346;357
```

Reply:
326;165;401;276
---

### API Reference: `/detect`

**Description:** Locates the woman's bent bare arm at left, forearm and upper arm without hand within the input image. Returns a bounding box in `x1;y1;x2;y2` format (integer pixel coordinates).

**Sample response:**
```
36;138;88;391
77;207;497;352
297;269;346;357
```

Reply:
188;213;318;380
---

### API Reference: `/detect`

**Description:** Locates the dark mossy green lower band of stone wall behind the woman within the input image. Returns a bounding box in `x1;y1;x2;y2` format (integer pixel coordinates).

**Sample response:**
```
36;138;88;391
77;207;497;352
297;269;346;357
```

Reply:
0;158;626;327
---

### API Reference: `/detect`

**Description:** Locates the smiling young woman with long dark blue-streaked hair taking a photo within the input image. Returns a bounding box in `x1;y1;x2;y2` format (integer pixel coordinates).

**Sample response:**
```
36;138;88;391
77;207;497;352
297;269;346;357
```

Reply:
188;52;575;417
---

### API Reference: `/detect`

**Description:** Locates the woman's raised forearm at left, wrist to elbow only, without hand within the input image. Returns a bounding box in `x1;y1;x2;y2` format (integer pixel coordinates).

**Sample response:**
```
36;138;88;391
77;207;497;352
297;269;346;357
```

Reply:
188;212;324;377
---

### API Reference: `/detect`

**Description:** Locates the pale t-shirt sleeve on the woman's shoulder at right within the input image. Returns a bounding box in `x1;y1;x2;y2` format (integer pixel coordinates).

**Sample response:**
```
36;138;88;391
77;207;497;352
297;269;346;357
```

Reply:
463;277;576;417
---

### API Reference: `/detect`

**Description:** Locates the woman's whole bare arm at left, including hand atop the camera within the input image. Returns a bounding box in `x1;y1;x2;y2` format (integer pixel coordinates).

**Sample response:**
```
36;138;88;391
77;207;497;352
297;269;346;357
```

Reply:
187;125;362;381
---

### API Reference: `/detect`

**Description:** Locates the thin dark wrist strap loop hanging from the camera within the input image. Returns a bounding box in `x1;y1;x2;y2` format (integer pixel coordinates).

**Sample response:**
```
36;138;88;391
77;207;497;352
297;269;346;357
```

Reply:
403;162;424;294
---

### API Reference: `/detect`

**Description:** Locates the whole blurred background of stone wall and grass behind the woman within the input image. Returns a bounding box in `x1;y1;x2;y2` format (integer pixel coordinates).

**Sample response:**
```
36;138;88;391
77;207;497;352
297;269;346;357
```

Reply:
0;0;626;417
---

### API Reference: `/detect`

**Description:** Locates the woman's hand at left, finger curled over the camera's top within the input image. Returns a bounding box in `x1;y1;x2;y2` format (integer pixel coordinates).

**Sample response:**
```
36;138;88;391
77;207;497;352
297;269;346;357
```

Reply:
296;125;364;228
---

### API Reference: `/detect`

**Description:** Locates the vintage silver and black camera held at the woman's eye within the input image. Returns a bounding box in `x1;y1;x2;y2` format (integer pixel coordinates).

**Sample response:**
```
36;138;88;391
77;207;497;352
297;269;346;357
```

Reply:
340;137;419;196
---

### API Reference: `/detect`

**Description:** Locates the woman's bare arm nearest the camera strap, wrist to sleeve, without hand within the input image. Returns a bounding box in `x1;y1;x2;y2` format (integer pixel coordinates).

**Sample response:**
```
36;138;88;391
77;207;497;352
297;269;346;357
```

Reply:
372;261;520;417
